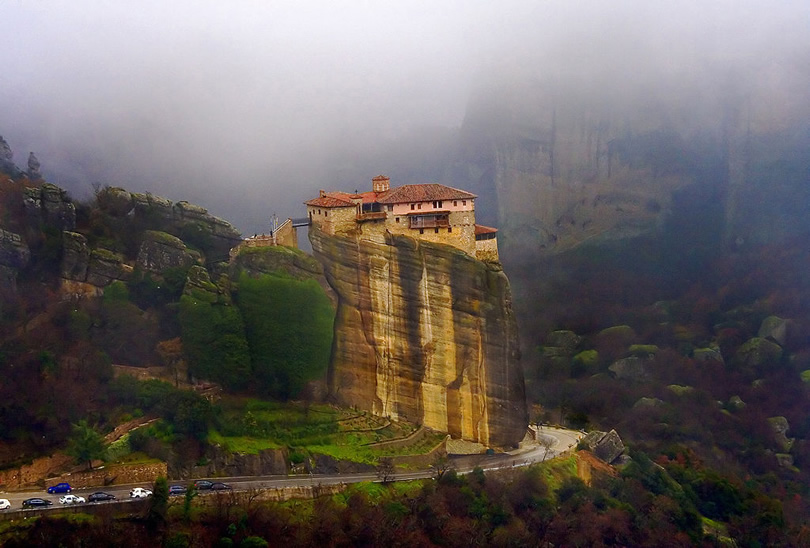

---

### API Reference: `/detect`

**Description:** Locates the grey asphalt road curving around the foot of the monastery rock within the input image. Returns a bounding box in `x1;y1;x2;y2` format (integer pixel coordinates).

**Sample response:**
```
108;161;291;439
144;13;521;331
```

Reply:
0;426;583;515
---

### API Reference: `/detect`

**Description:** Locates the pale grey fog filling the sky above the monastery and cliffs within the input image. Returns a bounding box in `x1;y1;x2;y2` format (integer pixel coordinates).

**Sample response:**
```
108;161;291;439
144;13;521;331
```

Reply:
0;0;810;233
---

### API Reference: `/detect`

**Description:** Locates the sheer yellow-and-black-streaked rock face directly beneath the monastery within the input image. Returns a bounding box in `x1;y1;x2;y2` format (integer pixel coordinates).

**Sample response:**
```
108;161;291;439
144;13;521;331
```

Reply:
310;227;528;447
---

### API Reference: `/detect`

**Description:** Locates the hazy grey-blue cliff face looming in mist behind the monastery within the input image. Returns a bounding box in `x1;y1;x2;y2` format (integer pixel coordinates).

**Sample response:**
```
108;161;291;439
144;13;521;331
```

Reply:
446;73;810;258
